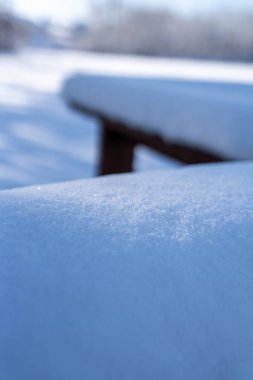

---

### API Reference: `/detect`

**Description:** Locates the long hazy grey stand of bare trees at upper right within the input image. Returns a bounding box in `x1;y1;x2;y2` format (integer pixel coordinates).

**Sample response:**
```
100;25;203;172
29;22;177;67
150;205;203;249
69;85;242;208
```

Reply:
78;6;253;60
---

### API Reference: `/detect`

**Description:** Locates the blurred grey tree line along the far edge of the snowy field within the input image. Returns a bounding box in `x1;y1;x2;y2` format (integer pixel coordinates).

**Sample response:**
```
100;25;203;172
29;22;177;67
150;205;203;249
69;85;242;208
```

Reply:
0;0;253;61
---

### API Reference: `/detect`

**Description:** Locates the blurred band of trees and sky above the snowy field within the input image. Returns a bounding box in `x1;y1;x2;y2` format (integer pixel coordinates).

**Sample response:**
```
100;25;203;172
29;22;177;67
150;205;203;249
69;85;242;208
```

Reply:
0;0;253;61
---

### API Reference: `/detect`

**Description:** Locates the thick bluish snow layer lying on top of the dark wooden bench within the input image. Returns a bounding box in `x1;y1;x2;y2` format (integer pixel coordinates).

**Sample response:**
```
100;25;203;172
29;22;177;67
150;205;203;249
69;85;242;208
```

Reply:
63;62;253;159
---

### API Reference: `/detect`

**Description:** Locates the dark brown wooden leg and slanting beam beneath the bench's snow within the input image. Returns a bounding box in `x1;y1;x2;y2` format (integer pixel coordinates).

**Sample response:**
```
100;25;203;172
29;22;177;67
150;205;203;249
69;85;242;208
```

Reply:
67;102;229;175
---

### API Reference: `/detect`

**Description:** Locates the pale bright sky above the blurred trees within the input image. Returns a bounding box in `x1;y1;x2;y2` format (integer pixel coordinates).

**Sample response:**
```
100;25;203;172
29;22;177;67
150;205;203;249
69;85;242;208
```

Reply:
11;0;253;23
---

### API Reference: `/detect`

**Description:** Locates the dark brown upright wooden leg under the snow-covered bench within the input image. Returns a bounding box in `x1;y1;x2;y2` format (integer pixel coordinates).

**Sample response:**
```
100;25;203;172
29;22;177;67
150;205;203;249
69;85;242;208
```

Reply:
98;121;136;175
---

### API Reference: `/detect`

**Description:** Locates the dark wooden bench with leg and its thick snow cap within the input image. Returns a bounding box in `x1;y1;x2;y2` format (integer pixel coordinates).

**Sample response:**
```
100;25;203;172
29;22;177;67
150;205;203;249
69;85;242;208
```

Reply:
63;68;253;174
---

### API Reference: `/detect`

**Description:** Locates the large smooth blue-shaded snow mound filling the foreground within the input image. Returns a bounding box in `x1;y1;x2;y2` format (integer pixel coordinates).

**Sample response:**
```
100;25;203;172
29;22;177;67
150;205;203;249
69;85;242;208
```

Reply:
0;163;253;380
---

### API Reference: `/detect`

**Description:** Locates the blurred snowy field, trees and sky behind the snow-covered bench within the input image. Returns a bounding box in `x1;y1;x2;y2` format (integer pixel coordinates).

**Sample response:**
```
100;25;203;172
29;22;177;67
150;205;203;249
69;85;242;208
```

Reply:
0;0;253;189
